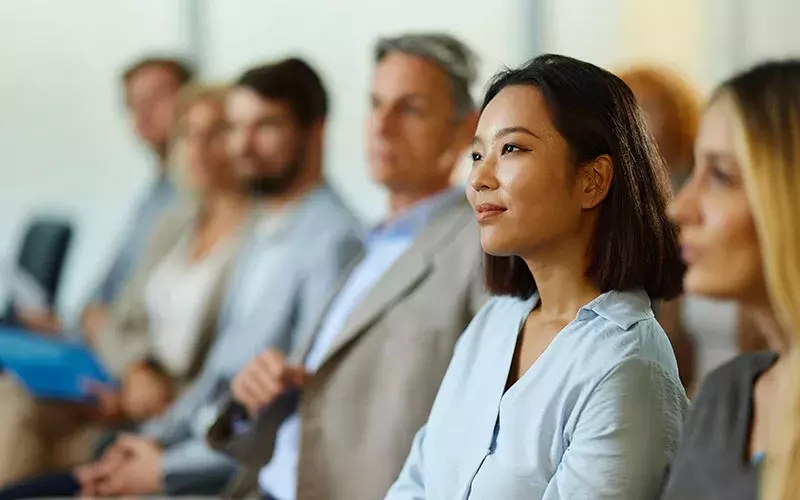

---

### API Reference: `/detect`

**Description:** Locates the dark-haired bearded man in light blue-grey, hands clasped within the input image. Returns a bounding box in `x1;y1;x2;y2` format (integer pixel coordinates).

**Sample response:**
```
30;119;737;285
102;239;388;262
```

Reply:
0;59;361;498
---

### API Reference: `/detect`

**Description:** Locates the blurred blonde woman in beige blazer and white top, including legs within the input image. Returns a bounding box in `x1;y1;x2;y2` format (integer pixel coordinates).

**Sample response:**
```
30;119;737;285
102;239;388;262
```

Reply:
0;87;249;484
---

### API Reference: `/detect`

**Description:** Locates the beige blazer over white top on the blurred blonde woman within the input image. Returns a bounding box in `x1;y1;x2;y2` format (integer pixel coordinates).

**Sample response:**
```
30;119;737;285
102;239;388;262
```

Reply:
94;202;252;388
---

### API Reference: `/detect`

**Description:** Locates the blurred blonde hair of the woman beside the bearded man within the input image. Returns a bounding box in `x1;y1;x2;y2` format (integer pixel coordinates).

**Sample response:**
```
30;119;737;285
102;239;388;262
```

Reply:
167;84;229;197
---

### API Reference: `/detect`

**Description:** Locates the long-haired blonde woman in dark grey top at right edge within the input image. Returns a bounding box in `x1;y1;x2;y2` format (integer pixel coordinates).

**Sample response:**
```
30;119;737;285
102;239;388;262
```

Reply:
663;61;800;500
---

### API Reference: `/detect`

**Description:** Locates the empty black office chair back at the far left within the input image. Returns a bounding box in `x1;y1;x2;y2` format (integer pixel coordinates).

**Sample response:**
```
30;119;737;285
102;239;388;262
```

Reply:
2;217;72;325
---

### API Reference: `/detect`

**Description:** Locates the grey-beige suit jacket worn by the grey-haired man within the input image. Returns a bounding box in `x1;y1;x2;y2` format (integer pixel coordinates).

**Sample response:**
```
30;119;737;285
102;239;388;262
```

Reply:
209;192;488;500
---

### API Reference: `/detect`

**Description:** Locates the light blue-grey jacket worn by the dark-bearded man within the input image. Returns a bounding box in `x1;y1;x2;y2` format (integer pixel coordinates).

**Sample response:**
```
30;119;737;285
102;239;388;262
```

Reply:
141;187;362;493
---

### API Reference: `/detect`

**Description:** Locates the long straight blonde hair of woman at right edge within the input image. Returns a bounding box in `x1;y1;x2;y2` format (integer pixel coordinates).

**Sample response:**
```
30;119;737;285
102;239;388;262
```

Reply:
714;60;800;500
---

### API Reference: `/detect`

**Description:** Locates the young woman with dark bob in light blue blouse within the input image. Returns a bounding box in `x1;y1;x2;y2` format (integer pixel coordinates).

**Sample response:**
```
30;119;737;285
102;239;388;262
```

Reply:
387;55;687;500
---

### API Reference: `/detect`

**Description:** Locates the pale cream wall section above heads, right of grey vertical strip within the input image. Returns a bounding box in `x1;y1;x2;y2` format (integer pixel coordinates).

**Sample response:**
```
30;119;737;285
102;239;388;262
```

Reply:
533;0;800;98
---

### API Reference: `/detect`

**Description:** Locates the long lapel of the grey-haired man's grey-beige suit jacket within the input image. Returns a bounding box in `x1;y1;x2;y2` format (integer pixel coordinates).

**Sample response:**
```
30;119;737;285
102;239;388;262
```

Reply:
320;198;466;368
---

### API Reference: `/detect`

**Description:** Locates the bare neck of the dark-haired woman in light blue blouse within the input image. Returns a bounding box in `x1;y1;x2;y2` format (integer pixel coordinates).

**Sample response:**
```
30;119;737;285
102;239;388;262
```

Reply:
523;239;601;322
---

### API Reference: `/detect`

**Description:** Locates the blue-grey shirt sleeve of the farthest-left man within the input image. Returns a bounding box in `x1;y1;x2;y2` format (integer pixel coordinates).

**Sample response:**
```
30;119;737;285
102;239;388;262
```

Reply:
91;175;176;304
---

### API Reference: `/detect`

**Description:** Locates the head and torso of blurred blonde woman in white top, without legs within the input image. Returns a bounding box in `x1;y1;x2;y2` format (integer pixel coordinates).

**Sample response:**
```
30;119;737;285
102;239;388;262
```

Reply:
92;86;250;421
